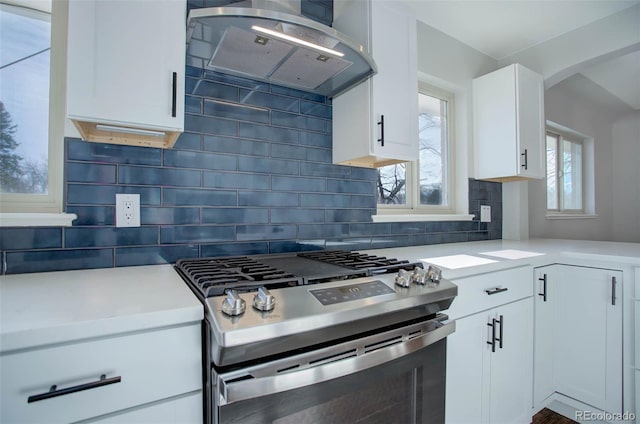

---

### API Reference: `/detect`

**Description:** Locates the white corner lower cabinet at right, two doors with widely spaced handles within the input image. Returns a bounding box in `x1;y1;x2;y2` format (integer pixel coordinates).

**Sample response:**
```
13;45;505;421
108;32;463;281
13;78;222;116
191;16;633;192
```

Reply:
534;265;623;413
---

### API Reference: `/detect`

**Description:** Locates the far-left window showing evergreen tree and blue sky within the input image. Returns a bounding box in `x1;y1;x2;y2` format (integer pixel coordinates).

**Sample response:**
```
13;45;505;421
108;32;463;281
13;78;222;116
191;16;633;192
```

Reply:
0;0;69;225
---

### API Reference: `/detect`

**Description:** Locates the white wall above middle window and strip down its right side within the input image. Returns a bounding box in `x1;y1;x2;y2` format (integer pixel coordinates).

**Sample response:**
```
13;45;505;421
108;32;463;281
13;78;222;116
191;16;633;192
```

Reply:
417;21;498;214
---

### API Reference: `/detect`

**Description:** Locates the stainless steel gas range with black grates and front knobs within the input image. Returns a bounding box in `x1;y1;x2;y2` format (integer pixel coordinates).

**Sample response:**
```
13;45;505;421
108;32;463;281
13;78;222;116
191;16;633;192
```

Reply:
176;251;457;424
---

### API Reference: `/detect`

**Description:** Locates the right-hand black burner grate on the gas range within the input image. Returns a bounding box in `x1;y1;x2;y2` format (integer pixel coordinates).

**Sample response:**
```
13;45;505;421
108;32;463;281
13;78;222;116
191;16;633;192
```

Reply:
298;250;422;275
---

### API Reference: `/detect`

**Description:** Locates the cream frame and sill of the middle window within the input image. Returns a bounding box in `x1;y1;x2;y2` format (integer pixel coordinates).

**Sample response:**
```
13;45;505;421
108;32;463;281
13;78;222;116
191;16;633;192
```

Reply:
377;81;460;220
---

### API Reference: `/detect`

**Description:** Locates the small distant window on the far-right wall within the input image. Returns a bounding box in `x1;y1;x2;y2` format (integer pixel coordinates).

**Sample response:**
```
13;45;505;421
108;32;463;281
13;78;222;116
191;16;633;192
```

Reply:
546;132;584;213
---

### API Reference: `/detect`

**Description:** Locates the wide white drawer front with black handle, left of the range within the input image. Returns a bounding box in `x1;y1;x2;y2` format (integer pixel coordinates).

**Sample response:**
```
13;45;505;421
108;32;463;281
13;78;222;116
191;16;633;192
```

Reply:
0;324;202;423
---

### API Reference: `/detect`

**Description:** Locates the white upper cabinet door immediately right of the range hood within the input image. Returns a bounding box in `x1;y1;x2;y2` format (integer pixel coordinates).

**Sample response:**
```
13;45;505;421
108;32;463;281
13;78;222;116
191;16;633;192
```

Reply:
371;2;418;160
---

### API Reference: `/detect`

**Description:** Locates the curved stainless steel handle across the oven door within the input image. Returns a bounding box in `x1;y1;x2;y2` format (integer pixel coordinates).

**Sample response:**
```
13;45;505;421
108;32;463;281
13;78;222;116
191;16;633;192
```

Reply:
218;321;456;406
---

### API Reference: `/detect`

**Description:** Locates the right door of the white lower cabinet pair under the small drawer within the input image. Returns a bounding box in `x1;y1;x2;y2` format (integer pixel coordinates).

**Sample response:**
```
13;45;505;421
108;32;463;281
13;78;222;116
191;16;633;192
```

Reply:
486;298;533;424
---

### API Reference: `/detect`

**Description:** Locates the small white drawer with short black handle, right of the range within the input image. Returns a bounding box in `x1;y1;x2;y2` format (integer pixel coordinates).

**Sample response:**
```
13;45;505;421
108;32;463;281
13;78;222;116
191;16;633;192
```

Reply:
446;267;533;319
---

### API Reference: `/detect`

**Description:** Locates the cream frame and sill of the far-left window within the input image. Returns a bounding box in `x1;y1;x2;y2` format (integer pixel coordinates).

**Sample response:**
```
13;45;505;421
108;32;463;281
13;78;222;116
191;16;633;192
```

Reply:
0;0;76;227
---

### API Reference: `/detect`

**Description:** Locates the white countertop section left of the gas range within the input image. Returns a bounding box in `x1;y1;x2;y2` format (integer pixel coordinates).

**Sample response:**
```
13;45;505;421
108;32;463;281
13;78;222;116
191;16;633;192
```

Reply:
0;265;204;353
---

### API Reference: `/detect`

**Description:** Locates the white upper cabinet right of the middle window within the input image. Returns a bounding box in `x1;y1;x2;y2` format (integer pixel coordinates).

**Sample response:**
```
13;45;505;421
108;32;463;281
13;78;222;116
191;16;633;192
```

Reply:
473;64;545;181
